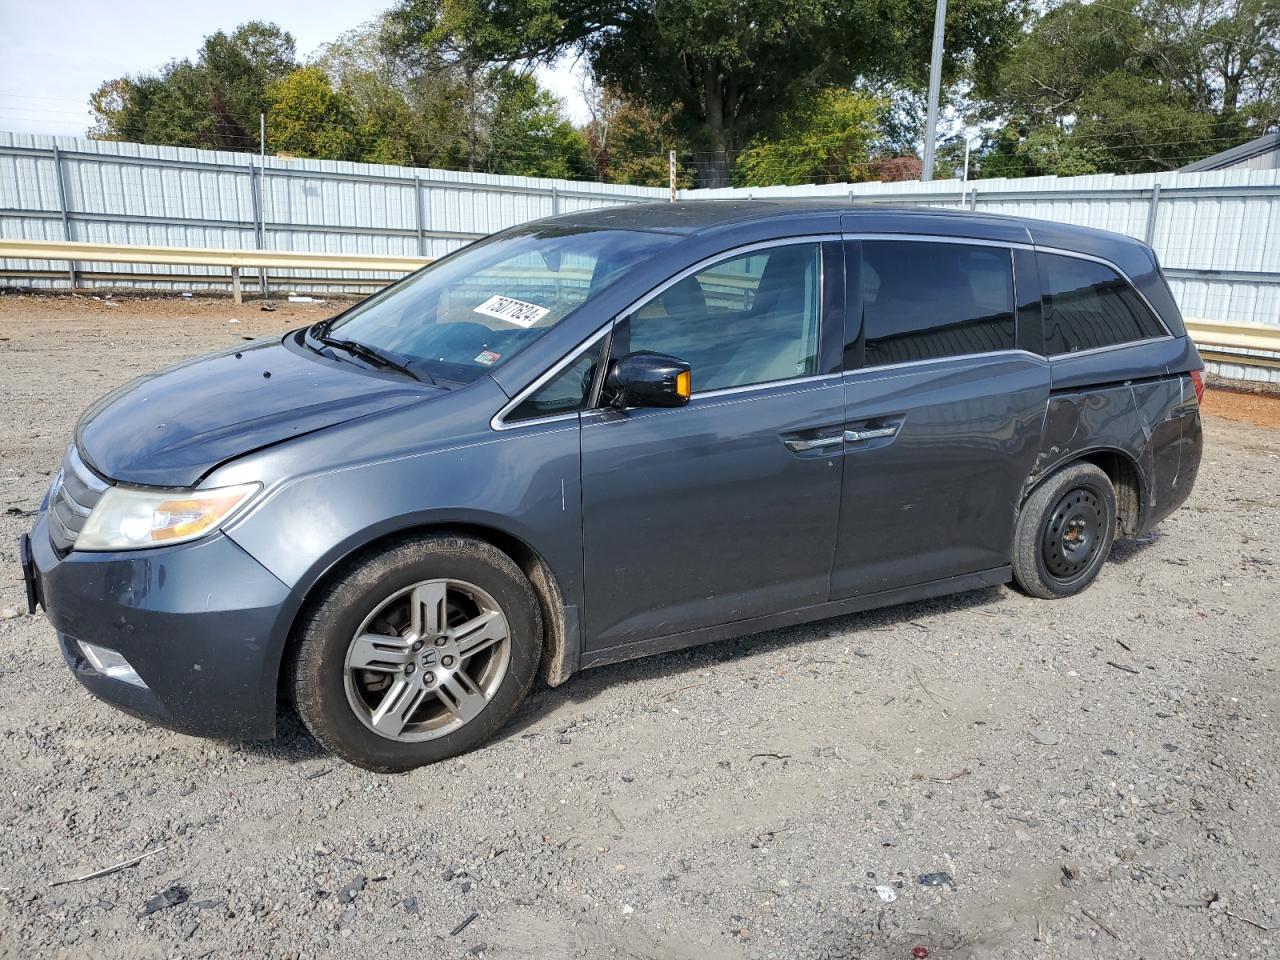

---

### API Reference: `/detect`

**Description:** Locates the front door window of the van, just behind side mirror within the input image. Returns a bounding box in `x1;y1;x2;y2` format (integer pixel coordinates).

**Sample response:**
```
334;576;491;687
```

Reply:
625;243;822;393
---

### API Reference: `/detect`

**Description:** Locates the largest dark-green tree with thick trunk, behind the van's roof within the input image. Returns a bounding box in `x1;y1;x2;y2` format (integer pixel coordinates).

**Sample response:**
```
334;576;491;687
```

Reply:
394;0;1024;186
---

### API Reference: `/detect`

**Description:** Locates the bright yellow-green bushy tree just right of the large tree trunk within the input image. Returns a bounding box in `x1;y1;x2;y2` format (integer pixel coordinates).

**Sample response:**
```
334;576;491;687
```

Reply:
735;90;884;187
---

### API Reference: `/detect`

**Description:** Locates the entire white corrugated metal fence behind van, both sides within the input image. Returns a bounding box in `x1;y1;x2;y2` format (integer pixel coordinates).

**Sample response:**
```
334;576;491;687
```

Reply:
0;133;1280;381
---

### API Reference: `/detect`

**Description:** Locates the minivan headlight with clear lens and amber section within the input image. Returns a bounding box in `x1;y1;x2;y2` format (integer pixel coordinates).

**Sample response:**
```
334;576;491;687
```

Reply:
76;484;261;550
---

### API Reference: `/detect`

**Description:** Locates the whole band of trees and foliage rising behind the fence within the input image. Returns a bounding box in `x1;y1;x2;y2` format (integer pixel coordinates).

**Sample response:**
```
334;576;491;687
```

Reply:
82;0;1280;186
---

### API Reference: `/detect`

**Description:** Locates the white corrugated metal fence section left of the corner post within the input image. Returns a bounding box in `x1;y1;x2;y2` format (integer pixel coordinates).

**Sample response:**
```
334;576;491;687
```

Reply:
0;133;667;291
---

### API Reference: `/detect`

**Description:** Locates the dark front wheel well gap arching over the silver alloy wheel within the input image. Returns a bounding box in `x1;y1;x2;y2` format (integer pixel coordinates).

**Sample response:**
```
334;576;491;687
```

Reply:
276;520;581;716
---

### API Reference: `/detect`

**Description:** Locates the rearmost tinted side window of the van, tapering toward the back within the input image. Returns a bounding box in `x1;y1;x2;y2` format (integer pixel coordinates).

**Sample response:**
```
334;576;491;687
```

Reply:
1038;253;1165;355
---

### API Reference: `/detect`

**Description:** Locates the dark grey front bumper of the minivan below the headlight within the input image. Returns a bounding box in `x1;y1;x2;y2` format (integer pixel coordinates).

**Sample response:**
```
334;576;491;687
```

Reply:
24;513;298;739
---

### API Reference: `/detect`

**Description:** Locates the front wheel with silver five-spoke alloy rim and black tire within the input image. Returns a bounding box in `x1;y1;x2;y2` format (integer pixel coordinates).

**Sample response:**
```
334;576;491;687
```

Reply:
291;534;543;773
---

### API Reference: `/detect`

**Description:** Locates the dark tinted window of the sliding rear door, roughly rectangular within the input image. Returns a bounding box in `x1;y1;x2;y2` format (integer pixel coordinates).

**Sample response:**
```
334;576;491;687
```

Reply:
863;241;1014;366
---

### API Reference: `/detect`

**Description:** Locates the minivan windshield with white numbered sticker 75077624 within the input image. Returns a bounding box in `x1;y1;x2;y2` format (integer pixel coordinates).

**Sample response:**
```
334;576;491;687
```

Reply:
316;224;677;383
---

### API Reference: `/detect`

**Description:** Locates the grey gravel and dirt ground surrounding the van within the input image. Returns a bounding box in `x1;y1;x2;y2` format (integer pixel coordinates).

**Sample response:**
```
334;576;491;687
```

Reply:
0;296;1280;960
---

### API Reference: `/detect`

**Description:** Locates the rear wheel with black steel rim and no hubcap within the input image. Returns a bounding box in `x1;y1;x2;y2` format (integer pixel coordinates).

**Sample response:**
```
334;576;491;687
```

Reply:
1014;463;1116;600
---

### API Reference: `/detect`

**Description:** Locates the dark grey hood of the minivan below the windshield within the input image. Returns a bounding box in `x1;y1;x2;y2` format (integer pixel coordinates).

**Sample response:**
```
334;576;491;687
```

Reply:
76;334;442;486
